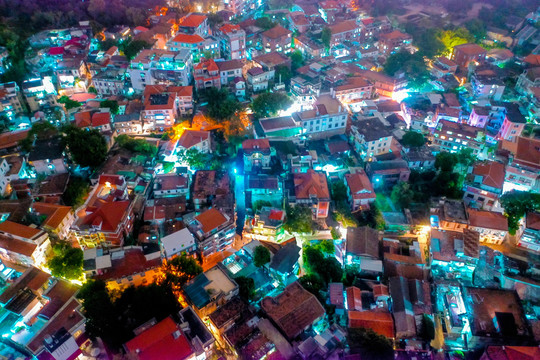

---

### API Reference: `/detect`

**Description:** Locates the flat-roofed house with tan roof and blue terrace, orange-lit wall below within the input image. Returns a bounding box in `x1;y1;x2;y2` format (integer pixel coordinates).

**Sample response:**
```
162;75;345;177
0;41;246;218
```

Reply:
183;263;239;317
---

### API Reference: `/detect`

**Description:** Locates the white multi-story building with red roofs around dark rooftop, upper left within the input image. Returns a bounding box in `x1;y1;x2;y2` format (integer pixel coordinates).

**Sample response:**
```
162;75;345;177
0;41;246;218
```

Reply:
141;85;193;129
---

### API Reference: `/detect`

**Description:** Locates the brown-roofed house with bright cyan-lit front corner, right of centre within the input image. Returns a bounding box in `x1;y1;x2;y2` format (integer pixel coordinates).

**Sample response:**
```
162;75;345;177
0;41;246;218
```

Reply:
344;226;383;274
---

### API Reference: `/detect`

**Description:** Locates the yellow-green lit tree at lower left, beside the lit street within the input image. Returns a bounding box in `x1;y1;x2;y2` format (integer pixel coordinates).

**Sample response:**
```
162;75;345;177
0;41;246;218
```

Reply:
47;243;83;280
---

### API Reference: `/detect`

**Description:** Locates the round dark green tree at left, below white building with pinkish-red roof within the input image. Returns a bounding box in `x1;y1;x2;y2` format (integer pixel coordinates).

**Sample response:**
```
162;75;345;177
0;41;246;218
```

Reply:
64;126;107;168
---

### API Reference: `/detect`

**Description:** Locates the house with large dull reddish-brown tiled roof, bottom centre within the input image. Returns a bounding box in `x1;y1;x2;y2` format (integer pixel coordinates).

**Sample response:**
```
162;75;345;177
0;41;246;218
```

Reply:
261;282;325;340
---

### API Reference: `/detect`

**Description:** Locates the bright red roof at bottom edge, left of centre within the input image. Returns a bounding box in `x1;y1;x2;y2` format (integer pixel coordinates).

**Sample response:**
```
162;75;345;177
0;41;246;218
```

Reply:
124;317;193;360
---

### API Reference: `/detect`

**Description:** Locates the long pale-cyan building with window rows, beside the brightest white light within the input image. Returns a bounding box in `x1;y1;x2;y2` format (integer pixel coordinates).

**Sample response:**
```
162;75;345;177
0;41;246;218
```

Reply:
292;95;349;138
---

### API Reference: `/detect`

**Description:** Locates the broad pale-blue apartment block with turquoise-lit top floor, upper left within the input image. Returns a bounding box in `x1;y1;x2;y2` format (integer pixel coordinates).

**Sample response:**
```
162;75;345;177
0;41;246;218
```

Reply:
128;49;192;92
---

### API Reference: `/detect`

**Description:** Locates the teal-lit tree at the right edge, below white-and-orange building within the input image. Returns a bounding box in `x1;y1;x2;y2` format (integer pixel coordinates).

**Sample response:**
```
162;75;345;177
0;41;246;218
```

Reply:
500;190;540;235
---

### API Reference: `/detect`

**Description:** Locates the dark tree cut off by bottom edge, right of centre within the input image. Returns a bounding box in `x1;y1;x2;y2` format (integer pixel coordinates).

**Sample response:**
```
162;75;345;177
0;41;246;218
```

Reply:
347;328;394;360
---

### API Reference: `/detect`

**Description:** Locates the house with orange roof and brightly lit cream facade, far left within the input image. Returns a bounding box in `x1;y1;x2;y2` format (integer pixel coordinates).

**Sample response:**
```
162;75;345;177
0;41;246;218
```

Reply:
32;202;75;240
